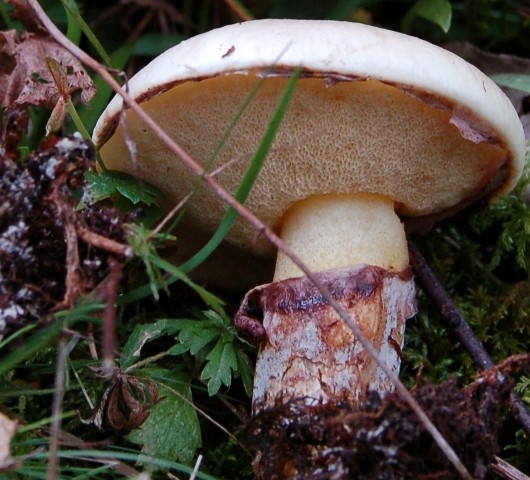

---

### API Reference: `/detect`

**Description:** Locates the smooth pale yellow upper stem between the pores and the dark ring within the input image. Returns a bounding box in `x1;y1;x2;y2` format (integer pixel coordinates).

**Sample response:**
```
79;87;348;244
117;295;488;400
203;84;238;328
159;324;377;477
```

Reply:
274;193;409;282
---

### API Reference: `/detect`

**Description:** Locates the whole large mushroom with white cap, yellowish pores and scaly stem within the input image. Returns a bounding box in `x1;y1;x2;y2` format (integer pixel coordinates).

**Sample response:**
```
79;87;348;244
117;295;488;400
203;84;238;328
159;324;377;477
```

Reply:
93;15;525;458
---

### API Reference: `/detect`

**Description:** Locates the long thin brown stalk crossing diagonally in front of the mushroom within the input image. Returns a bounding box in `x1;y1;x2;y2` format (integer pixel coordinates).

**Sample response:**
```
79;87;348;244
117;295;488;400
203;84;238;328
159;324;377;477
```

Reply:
28;0;473;480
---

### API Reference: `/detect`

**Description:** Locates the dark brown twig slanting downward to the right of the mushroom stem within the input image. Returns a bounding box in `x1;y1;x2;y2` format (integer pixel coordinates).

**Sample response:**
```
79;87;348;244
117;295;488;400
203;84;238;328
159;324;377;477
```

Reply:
409;240;530;435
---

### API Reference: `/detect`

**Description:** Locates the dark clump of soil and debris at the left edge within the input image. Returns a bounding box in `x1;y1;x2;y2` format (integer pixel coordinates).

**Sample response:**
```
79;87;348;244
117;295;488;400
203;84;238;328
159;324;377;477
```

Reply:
0;136;130;336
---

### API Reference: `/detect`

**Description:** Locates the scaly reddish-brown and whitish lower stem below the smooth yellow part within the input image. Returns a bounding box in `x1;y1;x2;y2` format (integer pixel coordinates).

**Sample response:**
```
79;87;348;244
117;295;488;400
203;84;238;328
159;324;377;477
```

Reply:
236;265;416;413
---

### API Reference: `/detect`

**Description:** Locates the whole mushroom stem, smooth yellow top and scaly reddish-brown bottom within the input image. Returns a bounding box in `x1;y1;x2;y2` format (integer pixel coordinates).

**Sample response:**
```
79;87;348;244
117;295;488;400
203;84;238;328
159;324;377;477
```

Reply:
248;194;416;412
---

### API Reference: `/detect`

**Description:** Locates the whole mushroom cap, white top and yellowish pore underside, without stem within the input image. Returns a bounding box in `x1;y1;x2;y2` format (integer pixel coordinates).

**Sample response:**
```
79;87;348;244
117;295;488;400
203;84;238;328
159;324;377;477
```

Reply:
93;20;525;253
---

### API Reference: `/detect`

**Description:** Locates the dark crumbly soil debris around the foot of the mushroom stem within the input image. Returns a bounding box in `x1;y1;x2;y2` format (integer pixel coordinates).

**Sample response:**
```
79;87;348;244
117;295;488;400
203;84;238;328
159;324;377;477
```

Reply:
244;356;529;480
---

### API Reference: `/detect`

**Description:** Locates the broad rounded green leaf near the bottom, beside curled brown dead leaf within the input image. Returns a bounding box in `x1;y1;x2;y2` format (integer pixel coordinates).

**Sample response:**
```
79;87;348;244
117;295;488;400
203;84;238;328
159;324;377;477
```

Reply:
127;369;201;465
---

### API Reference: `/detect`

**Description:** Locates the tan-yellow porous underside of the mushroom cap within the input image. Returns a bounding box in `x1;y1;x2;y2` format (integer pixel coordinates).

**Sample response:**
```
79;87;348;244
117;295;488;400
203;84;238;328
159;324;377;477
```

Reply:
101;74;506;255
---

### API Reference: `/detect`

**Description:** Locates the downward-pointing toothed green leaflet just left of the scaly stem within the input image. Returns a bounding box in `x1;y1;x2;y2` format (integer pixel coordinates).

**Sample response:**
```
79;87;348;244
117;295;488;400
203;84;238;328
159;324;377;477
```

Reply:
201;337;237;396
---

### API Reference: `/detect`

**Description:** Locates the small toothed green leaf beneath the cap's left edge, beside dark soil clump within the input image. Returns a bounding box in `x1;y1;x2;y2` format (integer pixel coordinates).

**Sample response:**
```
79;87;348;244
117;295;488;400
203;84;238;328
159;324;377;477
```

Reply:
85;170;162;205
